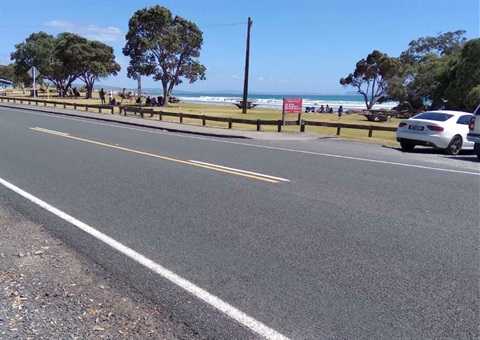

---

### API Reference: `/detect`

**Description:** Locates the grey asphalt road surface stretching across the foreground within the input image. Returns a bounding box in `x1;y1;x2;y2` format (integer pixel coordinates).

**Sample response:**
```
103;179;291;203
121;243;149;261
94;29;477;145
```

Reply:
0;108;480;339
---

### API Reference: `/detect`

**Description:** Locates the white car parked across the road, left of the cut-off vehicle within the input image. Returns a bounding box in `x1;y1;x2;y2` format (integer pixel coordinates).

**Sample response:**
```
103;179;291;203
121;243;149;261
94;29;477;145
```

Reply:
397;110;473;155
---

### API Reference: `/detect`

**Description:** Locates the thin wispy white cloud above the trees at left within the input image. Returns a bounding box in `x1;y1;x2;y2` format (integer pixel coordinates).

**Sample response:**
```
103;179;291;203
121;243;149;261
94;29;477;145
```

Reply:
43;20;124;42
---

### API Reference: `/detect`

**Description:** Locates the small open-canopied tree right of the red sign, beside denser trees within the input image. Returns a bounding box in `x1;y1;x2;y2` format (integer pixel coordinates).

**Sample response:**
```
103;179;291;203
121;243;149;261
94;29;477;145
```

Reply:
340;50;401;110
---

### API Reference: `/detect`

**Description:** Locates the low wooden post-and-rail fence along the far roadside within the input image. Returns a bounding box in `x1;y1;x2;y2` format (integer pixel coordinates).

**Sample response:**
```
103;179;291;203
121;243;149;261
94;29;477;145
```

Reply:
0;97;397;137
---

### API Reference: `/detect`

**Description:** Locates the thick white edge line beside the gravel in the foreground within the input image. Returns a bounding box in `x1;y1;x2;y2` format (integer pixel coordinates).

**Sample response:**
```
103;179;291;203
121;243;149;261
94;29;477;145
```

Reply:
0;178;288;340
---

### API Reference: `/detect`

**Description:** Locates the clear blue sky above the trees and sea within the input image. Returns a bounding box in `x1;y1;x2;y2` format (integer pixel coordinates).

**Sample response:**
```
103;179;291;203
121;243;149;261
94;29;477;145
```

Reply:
0;0;480;94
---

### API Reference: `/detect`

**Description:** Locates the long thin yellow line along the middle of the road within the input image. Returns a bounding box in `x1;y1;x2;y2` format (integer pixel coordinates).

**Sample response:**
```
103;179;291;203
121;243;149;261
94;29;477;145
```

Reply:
30;128;279;183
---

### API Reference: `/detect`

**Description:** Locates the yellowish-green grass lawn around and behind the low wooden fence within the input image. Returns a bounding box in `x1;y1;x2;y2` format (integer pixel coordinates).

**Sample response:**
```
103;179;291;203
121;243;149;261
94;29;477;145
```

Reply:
8;91;401;146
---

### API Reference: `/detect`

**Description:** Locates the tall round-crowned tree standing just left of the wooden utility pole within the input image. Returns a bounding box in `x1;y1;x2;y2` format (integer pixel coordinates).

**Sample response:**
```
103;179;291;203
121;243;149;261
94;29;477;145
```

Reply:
123;5;206;104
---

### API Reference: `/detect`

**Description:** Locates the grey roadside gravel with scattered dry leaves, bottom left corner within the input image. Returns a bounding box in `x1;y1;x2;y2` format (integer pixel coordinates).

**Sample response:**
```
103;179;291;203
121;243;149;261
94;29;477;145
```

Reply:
0;202;200;339
